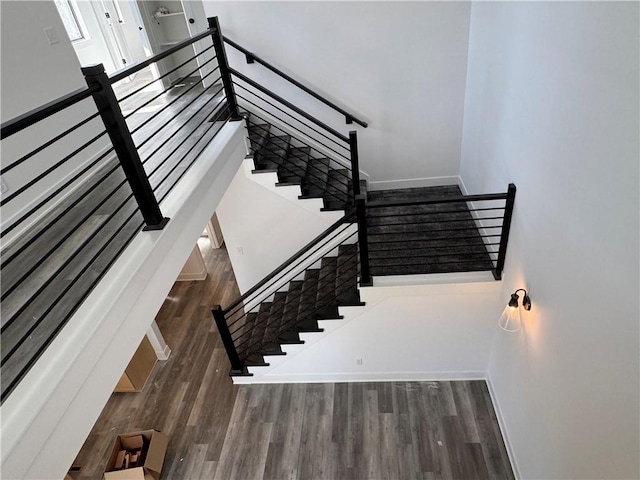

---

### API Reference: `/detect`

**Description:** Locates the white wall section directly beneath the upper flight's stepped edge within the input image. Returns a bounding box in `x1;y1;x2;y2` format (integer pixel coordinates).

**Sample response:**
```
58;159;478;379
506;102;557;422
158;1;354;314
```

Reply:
216;160;344;293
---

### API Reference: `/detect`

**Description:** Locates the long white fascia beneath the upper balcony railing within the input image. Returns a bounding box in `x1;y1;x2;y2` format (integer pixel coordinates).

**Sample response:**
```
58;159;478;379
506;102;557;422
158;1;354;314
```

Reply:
0;122;245;480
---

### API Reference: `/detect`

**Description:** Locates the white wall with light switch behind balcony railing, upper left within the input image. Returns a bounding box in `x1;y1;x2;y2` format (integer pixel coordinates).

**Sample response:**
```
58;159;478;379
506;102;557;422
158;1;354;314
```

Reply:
0;1;109;244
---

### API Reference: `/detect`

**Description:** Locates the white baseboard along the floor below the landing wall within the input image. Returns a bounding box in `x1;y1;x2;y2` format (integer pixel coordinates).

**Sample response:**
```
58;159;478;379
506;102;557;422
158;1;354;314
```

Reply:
232;367;487;385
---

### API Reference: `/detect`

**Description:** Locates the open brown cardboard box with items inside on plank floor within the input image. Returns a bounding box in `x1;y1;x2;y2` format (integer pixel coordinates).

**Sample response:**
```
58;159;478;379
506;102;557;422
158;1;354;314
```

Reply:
104;430;169;480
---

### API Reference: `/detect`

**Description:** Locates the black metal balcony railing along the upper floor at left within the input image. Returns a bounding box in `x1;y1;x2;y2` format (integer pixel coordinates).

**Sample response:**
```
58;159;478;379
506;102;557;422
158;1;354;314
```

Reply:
0;25;235;401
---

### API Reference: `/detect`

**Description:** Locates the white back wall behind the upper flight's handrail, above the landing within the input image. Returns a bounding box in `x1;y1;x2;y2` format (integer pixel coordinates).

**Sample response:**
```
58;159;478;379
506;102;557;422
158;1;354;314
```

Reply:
204;1;470;188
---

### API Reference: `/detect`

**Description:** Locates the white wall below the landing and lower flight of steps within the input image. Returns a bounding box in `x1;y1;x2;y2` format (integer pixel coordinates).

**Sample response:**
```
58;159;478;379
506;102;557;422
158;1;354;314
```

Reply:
234;281;503;383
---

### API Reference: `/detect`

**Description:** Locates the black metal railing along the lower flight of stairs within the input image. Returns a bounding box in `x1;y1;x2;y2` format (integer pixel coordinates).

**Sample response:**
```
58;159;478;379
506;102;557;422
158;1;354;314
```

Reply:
212;211;359;375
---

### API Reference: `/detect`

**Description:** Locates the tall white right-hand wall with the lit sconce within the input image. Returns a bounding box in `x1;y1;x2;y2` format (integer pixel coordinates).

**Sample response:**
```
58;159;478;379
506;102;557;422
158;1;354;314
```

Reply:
461;2;640;479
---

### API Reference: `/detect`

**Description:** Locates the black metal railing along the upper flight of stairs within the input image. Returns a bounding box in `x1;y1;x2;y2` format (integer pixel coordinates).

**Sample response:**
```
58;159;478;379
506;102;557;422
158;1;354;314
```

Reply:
220;26;368;208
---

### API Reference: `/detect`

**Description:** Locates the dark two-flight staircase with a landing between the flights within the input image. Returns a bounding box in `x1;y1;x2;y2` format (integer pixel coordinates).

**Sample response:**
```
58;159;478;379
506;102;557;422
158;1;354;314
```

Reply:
218;111;507;376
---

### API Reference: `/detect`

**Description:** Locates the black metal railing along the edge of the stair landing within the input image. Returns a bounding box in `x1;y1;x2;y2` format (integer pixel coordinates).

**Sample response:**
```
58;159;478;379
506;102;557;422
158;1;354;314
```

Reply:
356;184;516;286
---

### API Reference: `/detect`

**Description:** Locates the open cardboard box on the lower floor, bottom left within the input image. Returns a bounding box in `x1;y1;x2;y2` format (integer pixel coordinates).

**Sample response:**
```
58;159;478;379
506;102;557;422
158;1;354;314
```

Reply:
104;430;169;480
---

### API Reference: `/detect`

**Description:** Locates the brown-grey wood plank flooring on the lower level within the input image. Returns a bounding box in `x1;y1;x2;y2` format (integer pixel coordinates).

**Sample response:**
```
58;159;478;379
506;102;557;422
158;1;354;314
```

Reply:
76;240;513;480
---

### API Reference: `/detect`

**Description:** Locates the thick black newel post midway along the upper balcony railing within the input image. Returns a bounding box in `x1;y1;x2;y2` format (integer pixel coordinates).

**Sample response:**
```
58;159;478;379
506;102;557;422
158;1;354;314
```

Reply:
82;63;169;230
